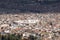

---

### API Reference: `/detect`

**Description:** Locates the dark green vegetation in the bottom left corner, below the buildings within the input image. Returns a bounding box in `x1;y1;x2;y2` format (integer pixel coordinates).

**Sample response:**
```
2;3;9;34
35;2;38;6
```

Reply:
0;34;22;40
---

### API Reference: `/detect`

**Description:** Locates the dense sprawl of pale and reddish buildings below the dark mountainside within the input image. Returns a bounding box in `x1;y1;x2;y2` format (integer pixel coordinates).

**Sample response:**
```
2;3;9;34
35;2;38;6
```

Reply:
0;13;60;40
